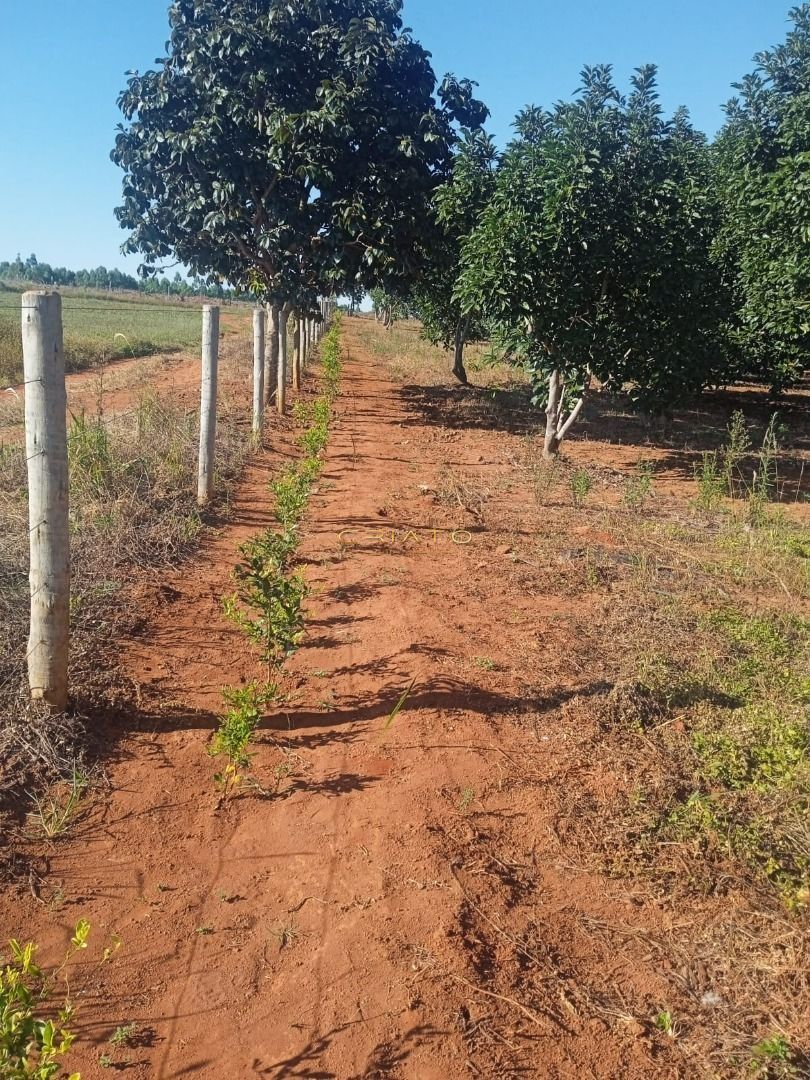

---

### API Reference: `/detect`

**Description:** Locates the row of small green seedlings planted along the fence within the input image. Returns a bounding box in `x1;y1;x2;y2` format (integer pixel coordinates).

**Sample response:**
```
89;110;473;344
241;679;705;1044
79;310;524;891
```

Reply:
208;315;341;798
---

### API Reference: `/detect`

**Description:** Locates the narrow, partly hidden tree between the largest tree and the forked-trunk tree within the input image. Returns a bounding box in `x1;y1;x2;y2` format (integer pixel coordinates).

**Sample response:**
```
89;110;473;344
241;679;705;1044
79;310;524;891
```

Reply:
411;131;497;383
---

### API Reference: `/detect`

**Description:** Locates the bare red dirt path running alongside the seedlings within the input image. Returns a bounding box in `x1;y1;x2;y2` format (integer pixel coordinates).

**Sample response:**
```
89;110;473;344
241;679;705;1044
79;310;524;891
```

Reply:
0;321;681;1080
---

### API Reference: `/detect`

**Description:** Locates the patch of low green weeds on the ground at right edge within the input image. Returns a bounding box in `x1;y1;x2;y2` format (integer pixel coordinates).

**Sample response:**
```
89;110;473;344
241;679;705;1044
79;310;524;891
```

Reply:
635;608;810;910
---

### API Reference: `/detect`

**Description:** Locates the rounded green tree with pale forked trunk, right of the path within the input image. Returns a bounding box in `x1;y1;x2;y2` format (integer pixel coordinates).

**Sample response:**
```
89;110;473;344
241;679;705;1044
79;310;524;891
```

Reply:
456;66;725;457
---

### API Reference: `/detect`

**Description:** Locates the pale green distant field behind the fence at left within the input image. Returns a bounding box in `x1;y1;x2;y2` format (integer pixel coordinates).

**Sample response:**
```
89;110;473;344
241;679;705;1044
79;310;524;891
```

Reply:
0;291;207;386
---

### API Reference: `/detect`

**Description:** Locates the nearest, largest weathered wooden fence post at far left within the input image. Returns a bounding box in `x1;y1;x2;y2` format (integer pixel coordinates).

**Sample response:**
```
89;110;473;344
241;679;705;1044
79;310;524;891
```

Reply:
22;292;70;711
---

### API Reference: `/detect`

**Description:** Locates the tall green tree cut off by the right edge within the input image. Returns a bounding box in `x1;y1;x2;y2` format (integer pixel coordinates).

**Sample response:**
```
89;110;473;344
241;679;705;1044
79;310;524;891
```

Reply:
716;3;810;392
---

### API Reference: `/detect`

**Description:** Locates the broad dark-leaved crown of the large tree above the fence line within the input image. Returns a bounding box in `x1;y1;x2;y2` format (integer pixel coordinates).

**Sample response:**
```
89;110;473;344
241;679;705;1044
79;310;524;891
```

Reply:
112;0;486;307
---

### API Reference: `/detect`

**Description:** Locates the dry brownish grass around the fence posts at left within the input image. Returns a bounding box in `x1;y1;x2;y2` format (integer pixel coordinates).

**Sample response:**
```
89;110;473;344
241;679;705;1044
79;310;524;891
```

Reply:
0;349;249;787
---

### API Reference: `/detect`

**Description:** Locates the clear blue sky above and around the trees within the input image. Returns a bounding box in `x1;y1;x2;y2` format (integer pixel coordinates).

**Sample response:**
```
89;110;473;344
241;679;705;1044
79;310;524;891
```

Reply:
0;0;793;270
